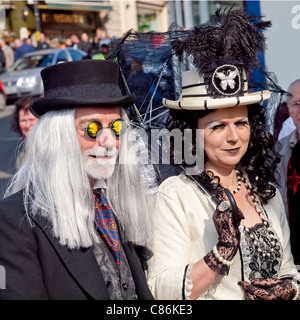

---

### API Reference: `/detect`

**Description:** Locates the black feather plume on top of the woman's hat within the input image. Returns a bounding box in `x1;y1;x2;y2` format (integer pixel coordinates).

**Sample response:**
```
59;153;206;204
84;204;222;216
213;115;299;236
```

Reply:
172;10;271;73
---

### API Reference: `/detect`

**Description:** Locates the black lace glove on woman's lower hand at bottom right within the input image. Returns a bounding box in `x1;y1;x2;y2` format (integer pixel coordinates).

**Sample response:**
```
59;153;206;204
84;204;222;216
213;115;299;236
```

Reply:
238;278;297;300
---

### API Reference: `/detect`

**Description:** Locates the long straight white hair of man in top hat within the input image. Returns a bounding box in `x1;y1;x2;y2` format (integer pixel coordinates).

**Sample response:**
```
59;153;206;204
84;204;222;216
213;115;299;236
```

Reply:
5;109;152;249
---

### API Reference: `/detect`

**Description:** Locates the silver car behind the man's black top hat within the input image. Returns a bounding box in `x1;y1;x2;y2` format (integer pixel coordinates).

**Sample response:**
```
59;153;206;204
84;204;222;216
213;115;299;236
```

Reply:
1;48;87;100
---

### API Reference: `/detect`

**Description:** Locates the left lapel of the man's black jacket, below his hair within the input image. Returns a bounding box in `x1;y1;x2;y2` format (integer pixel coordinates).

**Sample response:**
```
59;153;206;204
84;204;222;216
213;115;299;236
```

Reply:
34;216;110;300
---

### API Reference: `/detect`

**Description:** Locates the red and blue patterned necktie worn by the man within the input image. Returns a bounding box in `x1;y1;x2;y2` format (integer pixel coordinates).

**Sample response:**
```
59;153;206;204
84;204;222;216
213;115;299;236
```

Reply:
93;189;121;266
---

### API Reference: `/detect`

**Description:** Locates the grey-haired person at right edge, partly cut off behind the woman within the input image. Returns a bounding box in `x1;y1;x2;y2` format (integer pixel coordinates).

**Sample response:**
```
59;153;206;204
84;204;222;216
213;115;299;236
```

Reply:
275;79;300;214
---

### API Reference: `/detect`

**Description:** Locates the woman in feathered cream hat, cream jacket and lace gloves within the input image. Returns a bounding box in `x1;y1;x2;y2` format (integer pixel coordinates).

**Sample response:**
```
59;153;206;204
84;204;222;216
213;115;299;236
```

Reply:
148;11;299;299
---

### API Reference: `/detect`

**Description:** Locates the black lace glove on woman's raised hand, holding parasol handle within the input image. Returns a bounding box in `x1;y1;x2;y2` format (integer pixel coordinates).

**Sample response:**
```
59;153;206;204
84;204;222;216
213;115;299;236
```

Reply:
204;200;244;275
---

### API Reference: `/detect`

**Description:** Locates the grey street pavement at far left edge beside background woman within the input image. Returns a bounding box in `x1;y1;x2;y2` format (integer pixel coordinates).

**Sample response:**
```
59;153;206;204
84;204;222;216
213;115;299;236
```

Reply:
0;105;20;199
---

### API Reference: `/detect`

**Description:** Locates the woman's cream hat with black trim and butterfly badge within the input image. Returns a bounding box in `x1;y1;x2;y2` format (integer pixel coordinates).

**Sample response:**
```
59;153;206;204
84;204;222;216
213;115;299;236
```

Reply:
163;65;271;110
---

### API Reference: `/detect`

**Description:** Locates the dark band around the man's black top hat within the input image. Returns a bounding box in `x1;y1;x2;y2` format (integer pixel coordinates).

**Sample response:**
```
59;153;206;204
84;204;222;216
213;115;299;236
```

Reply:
44;83;122;100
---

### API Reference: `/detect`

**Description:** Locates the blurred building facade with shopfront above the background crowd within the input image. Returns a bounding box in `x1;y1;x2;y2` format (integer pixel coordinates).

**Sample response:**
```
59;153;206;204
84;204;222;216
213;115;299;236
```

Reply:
0;0;169;39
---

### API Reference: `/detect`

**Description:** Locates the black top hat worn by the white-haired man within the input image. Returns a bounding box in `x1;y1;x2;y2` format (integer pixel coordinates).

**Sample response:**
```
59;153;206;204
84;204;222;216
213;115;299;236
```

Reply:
30;60;136;117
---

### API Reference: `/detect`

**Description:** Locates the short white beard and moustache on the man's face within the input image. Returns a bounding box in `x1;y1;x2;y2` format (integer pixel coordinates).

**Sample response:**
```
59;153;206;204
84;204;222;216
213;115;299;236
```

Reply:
83;147;118;179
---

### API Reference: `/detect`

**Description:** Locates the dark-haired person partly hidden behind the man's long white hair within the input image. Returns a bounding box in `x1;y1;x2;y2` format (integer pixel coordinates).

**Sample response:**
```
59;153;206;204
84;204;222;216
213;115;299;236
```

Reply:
11;96;38;170
